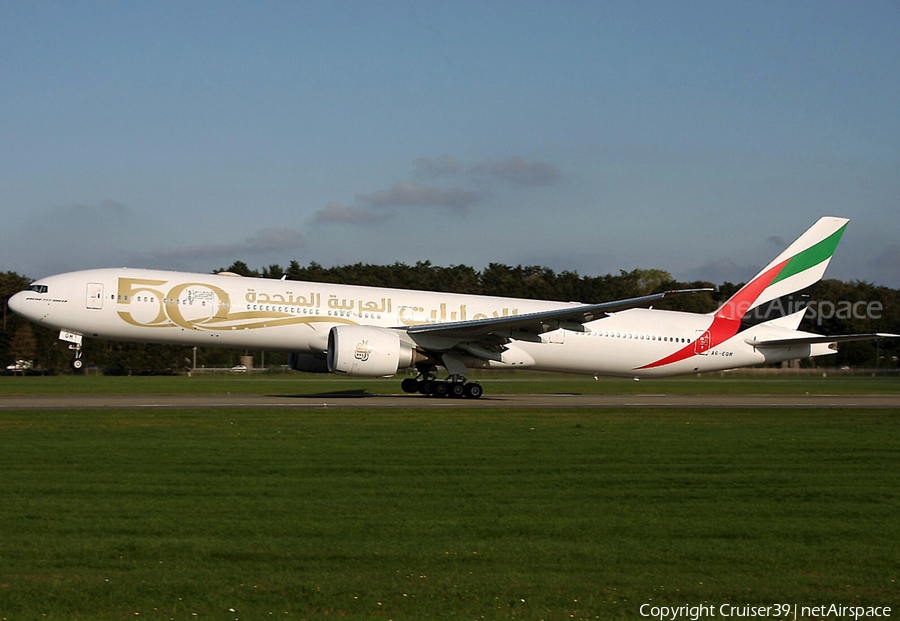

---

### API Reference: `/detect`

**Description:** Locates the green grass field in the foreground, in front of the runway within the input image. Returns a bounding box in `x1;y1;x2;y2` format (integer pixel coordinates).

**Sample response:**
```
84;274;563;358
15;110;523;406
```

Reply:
0;388;900;621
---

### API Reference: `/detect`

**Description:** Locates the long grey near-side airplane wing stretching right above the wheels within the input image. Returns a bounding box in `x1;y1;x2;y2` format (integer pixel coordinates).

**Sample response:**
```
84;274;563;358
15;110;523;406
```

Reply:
408;289;714;342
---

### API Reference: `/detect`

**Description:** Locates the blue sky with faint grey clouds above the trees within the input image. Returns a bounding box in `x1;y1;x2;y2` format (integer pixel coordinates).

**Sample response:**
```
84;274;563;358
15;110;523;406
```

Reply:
0;1;900;287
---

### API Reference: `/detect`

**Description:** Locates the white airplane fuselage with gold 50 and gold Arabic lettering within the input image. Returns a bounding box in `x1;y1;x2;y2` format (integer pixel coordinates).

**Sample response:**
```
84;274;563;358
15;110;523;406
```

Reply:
10;268;829;377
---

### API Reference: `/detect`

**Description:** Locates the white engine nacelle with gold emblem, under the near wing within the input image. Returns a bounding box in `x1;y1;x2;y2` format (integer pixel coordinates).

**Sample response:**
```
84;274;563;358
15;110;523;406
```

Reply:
328;326;416;377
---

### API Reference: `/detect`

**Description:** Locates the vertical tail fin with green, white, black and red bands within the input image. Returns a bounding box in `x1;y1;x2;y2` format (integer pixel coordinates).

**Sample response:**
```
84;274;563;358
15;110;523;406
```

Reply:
715;217;849;330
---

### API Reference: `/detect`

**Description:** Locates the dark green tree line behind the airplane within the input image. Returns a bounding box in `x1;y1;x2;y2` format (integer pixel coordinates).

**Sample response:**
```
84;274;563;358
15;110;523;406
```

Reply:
0;261;900;374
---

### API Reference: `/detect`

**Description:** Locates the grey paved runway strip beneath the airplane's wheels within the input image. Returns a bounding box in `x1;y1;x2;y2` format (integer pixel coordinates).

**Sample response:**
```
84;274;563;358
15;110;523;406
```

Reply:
0;391;900;410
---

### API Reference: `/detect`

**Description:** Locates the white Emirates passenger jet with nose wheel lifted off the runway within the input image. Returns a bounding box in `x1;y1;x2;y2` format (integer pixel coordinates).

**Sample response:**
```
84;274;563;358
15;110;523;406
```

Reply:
9;217;900;399
